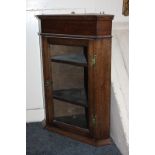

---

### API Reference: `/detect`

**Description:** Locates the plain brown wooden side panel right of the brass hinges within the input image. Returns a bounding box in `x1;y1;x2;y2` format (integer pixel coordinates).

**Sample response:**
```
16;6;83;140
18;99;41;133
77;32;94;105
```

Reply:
94;39;111;139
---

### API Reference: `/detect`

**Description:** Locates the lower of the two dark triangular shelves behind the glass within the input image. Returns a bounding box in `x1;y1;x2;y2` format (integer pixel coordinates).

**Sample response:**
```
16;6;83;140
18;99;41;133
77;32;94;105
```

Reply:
53;89;88;107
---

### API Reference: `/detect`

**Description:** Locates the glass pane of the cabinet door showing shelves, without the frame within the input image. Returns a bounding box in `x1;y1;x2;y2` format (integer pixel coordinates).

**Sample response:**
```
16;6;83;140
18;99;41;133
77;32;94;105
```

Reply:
50;45;88;128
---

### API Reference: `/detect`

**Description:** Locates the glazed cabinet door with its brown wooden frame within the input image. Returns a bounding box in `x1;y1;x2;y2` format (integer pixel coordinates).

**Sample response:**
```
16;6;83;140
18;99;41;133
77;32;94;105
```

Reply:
42;37;95;137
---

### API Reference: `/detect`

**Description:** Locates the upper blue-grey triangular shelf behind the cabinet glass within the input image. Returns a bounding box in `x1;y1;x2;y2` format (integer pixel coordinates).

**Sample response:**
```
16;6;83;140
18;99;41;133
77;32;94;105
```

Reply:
51;54;87;67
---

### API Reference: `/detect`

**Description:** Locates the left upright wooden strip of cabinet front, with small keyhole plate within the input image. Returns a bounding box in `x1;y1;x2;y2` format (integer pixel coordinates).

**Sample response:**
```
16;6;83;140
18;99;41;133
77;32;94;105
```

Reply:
42;37;53;124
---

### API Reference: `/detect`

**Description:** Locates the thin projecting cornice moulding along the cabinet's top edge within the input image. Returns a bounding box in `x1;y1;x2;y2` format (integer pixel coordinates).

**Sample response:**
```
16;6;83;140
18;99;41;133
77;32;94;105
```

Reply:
36;13;114;20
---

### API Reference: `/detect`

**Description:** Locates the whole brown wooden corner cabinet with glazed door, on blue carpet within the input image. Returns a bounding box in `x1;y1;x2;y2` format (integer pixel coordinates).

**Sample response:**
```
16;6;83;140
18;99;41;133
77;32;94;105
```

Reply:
37;14;113;146
